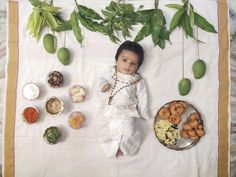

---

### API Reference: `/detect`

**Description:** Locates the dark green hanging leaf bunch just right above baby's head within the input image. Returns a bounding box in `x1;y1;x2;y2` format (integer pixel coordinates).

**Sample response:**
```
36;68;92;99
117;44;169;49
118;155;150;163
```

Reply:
134;0;170;49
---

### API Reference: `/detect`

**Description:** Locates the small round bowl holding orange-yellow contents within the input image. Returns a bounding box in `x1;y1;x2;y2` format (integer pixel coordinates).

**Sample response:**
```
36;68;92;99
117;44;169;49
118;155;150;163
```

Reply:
67;111;86;129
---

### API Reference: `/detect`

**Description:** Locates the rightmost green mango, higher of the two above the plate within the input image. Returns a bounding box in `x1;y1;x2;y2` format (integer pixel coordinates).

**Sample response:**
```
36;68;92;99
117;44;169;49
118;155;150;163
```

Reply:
192;59;206;79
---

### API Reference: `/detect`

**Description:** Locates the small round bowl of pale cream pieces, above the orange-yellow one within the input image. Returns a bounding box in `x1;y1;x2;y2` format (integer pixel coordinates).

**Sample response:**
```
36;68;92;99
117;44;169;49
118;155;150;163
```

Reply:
68;85;86;103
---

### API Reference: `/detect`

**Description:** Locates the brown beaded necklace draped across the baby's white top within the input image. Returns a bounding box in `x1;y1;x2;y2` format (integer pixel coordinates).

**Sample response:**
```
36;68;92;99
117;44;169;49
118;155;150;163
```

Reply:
108;67;142;105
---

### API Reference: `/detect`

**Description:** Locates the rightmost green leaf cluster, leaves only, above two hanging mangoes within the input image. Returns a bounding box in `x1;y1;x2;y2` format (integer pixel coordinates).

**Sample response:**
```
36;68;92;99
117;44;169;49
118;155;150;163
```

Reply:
166;0;217;40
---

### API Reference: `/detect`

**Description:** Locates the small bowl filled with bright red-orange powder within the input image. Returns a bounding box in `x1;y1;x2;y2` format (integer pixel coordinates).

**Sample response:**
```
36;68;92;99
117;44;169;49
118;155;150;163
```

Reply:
22;106;39;124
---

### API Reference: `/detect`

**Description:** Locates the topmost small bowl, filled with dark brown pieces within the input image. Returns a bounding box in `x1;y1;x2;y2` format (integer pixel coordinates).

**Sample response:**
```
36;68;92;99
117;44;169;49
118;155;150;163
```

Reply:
47;71;64;88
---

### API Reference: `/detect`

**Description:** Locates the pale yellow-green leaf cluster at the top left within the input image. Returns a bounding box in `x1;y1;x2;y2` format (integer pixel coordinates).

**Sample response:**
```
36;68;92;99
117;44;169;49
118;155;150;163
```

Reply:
26;0;64;40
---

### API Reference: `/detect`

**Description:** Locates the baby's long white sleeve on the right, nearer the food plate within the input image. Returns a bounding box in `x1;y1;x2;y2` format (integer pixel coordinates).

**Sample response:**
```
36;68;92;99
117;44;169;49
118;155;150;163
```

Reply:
136;79;151;119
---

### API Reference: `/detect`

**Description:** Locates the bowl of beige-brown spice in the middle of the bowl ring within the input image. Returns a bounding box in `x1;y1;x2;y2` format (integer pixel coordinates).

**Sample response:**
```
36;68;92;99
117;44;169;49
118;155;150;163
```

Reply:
45;96;64;116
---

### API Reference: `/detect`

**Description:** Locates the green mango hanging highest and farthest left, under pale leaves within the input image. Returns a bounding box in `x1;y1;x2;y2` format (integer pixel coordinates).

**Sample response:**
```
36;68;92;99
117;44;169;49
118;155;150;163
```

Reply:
43;33;56;53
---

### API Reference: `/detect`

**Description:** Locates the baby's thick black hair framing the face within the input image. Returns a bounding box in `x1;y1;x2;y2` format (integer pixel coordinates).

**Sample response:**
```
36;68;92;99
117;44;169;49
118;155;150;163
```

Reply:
115;41;144;68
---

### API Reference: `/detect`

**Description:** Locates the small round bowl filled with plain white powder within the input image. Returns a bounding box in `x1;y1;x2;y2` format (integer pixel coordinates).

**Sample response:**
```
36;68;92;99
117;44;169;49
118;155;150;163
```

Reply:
22;82;40;100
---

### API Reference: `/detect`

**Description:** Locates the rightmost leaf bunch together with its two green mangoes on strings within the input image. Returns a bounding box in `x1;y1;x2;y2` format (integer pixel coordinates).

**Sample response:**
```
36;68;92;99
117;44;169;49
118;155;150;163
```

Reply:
166;0;217;96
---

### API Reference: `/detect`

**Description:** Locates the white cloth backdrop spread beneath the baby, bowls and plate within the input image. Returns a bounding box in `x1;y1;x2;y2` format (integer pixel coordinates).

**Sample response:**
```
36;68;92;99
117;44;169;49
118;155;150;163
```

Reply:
11;0;219;177
